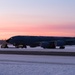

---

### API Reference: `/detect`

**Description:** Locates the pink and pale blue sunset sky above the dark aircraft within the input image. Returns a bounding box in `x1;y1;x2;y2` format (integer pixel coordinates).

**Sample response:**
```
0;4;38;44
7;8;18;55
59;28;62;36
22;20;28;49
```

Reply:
0;0;75;39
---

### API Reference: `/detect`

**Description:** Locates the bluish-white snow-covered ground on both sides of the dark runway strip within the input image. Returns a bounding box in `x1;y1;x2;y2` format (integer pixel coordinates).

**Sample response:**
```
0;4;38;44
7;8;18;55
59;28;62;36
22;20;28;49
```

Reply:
0;46;75;75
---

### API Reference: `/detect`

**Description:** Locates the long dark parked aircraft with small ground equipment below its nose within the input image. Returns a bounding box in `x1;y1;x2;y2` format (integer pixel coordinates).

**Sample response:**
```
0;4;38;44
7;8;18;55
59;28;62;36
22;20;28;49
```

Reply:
1;36;75;49
